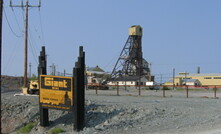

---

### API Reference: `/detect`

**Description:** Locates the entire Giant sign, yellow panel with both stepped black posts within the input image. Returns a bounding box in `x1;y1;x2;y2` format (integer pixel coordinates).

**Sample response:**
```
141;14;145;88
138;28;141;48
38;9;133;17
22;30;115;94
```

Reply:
38;46;85;131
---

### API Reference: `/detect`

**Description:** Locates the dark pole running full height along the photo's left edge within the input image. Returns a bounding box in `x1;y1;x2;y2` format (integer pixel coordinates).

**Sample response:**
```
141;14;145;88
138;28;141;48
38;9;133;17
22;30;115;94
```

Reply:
0;0;3;133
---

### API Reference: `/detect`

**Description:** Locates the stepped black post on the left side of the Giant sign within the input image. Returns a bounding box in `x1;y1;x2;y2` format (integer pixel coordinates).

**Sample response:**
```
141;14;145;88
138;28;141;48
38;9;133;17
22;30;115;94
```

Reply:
38;46;49;127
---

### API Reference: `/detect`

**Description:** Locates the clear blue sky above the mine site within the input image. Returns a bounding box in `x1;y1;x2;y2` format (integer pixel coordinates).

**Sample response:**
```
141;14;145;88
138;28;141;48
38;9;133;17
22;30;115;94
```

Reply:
2;0;221;82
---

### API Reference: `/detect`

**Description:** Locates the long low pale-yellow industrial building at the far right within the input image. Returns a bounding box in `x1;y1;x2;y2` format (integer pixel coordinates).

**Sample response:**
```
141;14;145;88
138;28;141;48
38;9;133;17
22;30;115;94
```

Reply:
164;73;221;86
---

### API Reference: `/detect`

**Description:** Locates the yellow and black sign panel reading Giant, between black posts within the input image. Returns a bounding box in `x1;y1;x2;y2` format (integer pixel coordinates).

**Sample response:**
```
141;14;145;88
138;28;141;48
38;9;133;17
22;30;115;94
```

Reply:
40;75;73;110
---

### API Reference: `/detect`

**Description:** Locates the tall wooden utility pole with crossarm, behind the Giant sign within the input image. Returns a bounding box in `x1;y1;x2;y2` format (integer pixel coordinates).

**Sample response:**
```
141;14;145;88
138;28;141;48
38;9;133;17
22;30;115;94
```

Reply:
10;0;41;87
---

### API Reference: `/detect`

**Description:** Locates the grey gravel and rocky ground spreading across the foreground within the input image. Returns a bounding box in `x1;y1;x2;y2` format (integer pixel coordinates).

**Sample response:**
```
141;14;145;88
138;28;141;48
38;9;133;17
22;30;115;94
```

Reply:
2;89;221;134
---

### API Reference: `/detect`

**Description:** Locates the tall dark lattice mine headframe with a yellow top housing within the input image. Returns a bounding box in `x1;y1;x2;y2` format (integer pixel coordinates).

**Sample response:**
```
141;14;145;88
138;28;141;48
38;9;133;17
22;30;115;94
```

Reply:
111;25;143;79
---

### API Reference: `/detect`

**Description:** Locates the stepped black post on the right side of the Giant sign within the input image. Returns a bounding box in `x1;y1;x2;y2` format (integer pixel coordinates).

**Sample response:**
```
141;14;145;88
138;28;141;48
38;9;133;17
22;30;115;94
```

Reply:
73;46;85;131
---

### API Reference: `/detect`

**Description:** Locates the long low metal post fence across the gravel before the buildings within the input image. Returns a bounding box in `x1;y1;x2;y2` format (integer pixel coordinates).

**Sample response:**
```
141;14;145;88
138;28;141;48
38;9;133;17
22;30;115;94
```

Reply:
86;85;221;99
